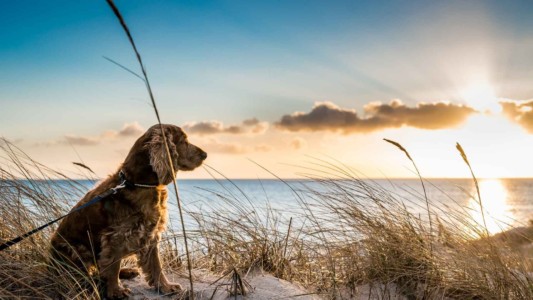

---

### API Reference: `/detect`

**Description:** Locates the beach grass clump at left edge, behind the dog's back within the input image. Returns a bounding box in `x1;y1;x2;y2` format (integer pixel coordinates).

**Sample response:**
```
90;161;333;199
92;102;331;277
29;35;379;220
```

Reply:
0;139;98;299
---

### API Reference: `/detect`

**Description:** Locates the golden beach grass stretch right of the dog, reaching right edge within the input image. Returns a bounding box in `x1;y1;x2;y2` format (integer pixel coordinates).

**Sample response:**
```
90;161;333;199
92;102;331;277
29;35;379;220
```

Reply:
180;165;533;299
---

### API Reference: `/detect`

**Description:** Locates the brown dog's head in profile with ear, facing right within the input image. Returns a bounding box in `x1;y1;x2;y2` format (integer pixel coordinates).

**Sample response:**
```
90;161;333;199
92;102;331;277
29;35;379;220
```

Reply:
124;124;207;185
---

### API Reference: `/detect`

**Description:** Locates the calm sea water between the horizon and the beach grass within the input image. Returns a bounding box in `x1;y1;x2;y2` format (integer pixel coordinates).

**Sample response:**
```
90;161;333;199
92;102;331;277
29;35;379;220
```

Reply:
16;179;533;233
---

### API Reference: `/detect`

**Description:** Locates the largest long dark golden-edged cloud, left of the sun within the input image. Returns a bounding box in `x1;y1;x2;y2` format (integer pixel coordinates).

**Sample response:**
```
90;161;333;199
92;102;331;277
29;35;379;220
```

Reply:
276;100;476;134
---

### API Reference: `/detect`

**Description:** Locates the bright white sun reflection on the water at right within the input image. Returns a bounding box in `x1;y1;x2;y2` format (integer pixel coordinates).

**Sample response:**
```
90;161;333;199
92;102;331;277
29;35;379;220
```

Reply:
468;179;514;234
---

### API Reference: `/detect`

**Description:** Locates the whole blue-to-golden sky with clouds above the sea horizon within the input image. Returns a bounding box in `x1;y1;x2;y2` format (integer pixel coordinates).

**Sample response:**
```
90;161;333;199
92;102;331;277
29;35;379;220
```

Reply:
0;0;533;178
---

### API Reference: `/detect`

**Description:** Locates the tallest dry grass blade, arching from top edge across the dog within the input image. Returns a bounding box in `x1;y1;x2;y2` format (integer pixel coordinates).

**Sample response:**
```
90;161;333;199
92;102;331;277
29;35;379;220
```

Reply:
106;0;194;298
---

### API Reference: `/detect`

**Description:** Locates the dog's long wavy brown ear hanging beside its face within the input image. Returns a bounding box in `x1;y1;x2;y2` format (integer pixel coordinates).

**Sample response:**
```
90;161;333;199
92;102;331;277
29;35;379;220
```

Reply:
146;127;179;185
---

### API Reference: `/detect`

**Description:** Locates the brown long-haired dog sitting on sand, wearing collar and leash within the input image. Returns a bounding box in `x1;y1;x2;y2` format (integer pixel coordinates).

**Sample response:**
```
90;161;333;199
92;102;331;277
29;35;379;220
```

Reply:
52;125;207;298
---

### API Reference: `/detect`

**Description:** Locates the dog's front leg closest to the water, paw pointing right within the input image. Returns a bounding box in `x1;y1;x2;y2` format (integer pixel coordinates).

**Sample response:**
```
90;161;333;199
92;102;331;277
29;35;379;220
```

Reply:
138;240;183;294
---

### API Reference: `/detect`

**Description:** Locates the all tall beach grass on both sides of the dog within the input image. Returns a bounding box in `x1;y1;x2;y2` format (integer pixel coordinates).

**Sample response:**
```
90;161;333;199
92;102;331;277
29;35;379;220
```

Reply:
0;141;533;299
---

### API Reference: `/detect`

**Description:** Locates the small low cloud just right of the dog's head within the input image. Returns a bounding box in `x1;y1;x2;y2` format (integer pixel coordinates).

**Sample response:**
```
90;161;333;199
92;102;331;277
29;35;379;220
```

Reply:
183;118;268;135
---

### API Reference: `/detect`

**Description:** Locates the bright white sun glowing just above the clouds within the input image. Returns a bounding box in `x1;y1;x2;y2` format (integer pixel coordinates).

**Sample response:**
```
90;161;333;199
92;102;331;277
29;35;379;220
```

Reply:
460;82;501;113
